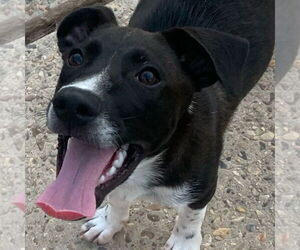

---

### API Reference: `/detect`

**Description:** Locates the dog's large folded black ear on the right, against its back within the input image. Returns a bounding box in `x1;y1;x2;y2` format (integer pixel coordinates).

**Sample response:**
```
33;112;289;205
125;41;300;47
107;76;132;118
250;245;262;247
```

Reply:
162;27;249;96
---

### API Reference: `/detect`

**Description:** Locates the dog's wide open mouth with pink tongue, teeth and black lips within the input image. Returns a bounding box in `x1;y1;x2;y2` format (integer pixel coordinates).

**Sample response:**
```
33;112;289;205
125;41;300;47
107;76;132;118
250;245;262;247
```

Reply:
36;136;143;220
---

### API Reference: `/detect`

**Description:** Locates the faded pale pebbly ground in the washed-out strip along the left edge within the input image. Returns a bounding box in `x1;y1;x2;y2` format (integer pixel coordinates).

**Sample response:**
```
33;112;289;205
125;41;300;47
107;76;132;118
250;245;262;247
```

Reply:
0;0;26;250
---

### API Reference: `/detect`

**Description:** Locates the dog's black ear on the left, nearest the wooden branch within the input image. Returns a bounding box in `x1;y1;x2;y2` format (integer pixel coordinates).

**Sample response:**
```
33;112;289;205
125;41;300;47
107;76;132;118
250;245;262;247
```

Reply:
57;6;117;50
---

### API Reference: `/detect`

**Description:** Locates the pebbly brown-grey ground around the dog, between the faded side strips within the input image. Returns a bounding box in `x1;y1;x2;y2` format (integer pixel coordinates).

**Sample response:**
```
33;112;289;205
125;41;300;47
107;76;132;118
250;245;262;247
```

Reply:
25;0;275;250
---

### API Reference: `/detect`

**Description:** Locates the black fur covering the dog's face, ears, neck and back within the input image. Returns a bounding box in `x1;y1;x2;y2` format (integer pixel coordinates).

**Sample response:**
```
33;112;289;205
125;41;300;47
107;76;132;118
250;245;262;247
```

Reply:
52;0;274;213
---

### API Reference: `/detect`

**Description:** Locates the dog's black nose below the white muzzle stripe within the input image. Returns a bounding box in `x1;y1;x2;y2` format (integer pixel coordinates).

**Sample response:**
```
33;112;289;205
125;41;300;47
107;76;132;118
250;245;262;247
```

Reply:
52;87;101;127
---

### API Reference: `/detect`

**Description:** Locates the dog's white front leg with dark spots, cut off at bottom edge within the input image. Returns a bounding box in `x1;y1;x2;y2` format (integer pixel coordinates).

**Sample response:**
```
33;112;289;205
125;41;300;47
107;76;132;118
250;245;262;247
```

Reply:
164;206;206;250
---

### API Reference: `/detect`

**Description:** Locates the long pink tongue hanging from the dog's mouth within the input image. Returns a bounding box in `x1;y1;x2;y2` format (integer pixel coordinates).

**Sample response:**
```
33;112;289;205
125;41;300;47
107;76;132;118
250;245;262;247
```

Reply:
36;138;116;220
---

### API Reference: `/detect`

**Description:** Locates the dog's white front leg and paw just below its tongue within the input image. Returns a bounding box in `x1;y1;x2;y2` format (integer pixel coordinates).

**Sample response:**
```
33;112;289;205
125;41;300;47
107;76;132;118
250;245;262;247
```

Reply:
81;189;131;244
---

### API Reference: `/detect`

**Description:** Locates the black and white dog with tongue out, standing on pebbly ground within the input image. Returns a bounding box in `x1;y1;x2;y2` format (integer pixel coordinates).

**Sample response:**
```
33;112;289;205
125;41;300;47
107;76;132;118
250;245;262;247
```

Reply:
38;0;274;250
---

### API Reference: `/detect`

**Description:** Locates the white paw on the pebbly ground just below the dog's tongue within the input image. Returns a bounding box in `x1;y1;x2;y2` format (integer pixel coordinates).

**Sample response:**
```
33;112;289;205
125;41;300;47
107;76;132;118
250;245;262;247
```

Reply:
81;206;123;244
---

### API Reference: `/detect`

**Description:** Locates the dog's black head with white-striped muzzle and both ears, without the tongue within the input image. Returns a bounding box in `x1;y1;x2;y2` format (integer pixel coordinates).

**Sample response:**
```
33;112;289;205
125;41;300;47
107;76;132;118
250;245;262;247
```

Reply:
40;7;248;220
